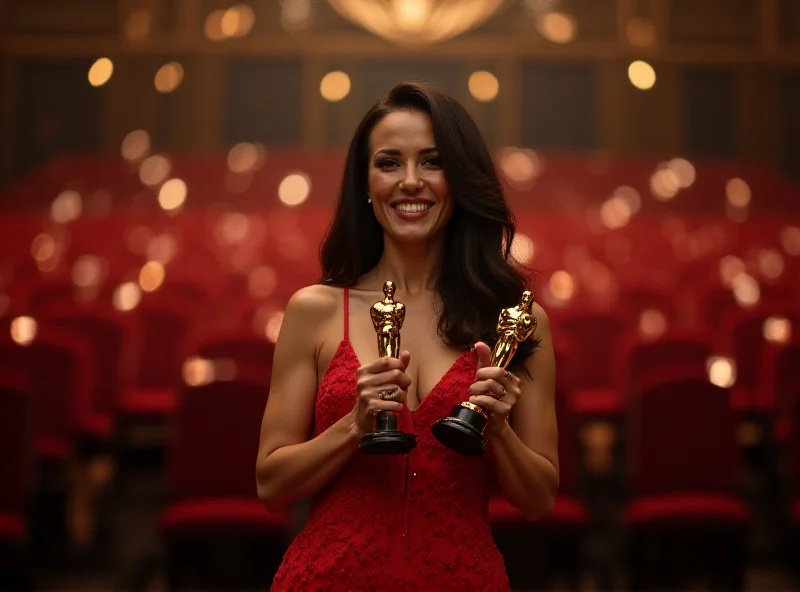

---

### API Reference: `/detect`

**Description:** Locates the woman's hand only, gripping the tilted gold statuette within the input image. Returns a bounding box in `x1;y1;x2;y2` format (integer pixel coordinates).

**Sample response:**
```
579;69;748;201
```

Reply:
469;341;522;435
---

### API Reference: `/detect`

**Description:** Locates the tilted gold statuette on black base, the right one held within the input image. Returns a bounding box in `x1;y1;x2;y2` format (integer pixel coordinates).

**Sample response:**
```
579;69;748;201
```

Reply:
431;290;537;457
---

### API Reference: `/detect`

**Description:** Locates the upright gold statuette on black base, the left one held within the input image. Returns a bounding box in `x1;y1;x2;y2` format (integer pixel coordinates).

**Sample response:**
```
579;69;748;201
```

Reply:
358;281;417;454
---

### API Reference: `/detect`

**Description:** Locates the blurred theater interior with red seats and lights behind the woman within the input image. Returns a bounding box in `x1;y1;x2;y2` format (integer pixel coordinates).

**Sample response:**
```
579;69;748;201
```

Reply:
0;0;800;590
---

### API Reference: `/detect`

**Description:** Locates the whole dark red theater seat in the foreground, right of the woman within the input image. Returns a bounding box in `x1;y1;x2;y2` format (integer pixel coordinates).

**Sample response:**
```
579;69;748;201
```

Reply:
624;375;751;590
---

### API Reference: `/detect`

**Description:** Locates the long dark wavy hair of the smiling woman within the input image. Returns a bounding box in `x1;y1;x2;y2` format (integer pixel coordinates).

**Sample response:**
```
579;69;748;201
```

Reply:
320;82;536;367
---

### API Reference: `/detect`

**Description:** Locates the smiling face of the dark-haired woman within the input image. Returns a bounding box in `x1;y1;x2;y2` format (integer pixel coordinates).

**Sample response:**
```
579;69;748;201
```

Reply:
368;110;453;242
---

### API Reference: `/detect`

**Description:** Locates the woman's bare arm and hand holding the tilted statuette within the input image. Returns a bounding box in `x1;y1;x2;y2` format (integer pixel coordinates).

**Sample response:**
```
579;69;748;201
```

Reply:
470;303;559;520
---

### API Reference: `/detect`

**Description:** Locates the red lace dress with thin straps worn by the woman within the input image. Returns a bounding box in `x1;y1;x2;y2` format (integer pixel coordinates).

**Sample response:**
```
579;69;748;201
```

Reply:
272;290;509;592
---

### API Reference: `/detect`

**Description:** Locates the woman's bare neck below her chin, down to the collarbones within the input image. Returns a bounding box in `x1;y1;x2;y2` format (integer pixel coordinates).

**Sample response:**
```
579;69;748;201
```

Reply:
363;237;442;296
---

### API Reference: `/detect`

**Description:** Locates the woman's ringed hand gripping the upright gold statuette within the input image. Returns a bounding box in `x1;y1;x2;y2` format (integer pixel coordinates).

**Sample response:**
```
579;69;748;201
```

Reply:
352;350;411;435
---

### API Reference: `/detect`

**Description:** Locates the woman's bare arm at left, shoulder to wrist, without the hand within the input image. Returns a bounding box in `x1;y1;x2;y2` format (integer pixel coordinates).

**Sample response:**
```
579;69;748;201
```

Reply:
256;286;363;510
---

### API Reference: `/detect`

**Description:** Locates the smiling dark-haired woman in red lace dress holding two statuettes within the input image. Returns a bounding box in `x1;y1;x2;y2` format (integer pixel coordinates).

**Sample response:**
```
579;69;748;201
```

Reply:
256;83;558;590
